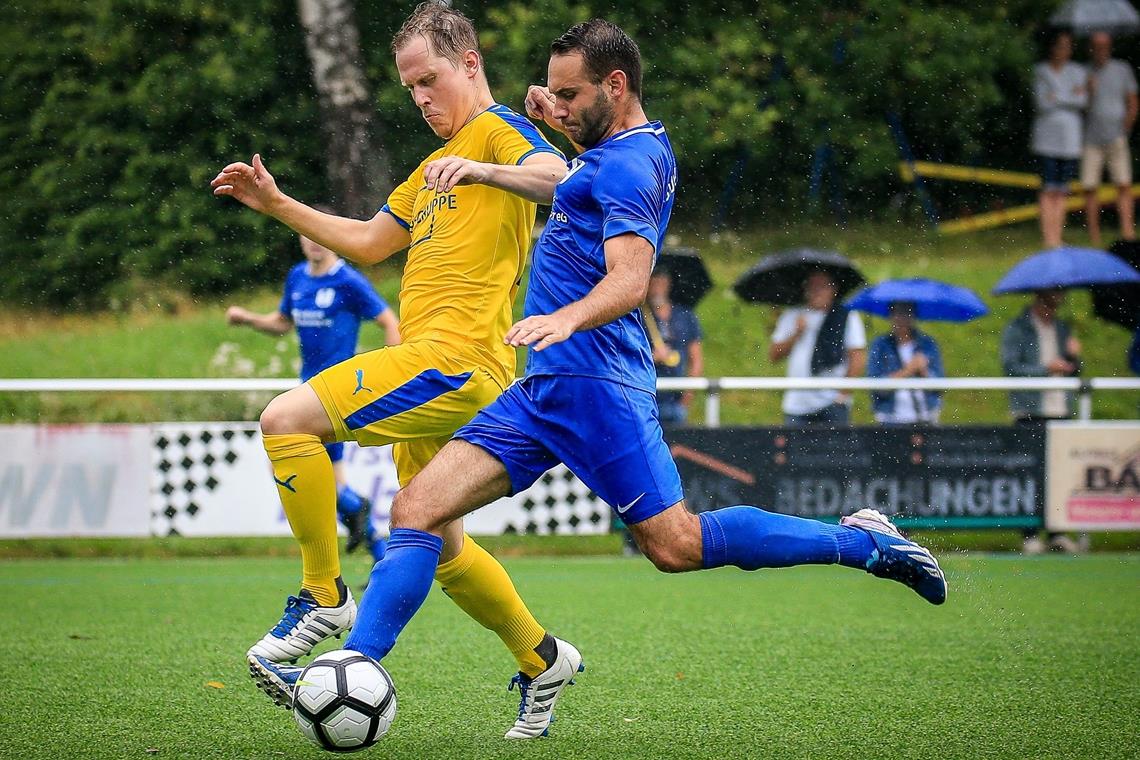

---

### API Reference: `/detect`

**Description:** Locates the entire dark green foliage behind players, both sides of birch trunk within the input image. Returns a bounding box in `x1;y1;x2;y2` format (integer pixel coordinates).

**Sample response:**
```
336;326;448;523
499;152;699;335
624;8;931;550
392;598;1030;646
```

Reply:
0;0;1103;308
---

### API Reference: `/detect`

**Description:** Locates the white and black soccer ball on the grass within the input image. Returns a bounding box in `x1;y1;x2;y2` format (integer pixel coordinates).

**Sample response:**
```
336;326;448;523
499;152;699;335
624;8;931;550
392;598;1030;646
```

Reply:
293;649;396;752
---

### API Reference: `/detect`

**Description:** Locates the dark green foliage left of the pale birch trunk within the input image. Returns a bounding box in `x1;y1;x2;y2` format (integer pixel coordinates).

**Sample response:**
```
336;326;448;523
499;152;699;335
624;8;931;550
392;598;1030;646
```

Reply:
0;0;323;305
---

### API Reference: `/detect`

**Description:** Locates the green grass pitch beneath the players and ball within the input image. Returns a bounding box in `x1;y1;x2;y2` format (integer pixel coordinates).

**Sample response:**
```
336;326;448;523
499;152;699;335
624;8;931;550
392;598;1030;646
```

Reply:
0;554;1140;760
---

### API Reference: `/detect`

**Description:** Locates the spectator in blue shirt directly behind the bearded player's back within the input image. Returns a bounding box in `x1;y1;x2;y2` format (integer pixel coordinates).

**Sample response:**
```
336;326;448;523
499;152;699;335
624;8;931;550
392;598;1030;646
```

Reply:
646;267;705;427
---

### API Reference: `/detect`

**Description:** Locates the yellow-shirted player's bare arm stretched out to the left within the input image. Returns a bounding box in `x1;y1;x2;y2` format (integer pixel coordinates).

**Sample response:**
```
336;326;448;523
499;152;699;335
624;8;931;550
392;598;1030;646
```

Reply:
210;154;412;264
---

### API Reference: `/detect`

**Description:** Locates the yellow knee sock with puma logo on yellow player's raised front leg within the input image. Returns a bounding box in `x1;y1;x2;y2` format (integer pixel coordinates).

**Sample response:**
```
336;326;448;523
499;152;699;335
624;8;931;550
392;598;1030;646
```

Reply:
262;434;341;607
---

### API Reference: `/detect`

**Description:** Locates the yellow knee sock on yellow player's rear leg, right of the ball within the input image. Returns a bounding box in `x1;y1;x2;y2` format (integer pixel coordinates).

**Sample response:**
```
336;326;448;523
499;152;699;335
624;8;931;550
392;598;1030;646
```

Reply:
435;534;547;678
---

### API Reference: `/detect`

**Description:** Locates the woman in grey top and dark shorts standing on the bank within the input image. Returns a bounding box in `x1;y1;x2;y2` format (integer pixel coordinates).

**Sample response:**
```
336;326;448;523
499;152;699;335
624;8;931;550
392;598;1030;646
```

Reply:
1032;31;1089;248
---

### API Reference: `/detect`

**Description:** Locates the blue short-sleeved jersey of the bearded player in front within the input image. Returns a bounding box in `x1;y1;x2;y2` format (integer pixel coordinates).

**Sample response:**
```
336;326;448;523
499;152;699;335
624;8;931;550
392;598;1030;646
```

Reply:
524;122;677;393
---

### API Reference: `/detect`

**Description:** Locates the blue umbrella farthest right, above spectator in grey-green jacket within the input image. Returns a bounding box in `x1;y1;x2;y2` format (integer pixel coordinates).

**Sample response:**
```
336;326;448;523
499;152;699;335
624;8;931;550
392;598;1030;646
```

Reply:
993;248;1140;295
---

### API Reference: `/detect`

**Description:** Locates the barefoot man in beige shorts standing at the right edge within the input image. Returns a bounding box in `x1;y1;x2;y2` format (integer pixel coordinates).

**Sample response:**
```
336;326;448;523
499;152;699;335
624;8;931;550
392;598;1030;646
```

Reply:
1081;32;1137;247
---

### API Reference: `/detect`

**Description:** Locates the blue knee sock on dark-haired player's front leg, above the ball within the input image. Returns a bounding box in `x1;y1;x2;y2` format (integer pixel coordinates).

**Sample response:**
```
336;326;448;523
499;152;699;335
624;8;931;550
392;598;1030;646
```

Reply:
344;528;443;660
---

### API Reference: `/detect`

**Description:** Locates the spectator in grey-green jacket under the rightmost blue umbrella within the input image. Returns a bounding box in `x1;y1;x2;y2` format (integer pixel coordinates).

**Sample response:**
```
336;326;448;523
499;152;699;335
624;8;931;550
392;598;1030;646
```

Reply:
1001;289;1081;554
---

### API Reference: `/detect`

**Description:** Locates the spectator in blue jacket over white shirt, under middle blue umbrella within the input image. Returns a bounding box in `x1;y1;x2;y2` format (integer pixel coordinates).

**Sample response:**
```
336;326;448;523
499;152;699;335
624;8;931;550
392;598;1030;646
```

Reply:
866;301;944;425
